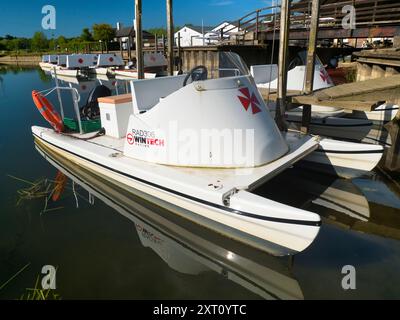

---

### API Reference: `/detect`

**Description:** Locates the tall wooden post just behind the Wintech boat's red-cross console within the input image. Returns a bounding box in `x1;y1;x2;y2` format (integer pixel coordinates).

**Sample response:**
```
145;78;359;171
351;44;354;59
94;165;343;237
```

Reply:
275;0;290;131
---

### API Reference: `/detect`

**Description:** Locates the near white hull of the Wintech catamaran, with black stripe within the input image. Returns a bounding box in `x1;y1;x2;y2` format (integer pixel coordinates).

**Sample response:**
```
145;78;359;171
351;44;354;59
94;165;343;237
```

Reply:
32;127;321;256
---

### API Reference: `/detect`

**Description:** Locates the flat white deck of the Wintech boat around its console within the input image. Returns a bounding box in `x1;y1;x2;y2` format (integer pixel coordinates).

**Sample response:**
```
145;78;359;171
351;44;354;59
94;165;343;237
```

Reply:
34;128;319;192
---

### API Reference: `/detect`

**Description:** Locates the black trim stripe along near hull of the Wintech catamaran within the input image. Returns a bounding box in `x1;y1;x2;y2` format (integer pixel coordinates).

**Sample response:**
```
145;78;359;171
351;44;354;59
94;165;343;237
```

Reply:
33;134;322;227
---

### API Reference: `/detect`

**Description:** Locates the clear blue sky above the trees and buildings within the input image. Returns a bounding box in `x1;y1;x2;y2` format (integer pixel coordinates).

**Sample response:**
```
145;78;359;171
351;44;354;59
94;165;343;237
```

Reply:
0;0;270;37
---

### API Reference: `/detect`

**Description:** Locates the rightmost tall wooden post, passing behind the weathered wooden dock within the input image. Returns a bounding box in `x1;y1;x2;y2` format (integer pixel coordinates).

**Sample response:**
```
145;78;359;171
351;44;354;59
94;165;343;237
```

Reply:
301;0;320;133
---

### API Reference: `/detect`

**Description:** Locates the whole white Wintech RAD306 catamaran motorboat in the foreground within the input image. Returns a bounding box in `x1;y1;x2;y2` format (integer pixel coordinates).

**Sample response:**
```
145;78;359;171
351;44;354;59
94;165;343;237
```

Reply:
28;53;383;255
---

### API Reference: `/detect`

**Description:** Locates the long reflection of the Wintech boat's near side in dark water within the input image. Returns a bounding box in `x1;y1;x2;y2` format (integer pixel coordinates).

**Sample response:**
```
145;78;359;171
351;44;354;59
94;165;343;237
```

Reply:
36;141;303;299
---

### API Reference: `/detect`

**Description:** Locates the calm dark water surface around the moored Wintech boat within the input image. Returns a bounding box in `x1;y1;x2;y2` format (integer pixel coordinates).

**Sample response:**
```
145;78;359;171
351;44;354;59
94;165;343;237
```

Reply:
0;67;400;299
